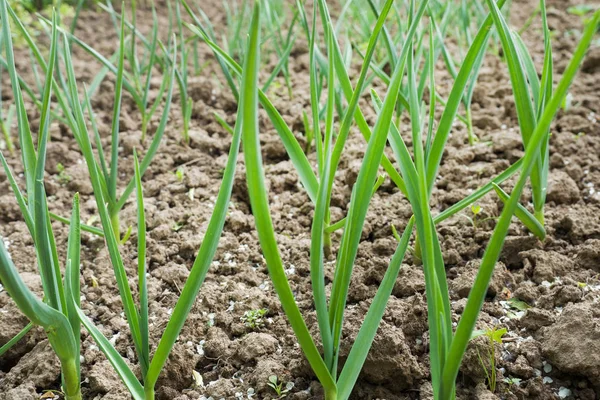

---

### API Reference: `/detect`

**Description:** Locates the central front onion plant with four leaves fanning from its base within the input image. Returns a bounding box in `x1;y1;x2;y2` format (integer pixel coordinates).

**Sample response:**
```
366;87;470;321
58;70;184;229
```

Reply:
236;1;418;399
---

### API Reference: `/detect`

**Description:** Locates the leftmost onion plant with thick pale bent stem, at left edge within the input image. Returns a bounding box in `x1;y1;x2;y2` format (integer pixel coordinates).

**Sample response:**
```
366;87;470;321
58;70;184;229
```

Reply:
0;7;81;400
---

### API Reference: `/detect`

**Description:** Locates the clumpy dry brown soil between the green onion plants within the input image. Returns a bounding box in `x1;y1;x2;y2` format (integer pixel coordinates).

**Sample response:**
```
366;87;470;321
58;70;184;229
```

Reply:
0;0;600;400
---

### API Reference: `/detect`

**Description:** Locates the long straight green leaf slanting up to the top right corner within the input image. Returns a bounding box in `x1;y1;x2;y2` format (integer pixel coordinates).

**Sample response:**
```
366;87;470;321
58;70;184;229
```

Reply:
440;10;600;400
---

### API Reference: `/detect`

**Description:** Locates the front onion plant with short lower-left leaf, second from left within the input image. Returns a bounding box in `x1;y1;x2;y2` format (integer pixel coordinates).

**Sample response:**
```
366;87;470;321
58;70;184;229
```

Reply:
56;3;259;400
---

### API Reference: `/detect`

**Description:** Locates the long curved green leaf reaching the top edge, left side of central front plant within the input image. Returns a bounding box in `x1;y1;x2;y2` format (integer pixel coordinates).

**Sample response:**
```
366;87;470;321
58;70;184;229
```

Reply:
237;2;336;398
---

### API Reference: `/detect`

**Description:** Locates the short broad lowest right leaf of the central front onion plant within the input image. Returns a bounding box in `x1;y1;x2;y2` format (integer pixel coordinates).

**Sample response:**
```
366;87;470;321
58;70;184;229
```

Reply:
338;218;414;400
